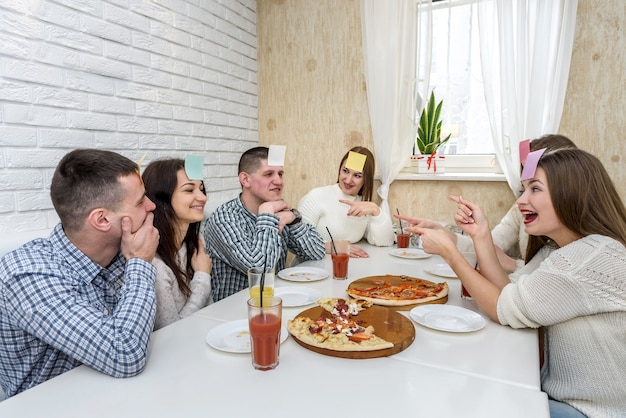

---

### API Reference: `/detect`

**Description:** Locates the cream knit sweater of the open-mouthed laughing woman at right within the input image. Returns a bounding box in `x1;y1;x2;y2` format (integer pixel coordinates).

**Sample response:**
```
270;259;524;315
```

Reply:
497;235;626;417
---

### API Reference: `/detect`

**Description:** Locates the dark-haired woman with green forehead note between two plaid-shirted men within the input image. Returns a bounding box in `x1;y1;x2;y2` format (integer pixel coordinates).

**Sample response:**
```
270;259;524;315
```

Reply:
142;159;212;330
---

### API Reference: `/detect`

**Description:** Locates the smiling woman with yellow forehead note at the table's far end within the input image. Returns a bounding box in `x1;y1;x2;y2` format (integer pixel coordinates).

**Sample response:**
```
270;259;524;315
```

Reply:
298;147;394;257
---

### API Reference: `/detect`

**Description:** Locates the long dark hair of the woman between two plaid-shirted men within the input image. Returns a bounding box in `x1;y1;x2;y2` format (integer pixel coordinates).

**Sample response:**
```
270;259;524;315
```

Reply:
142;159;204;297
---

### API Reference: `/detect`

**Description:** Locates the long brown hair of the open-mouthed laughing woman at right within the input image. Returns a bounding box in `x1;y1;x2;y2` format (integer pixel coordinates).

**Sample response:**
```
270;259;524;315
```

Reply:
526;149;626;262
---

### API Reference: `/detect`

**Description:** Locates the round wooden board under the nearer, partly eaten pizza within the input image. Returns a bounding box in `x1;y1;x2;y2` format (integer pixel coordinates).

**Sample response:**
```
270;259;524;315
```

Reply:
292;306;415;359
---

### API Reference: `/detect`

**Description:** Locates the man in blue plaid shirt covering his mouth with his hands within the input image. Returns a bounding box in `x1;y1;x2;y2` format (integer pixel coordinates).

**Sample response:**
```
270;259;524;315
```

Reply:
0;149;159;396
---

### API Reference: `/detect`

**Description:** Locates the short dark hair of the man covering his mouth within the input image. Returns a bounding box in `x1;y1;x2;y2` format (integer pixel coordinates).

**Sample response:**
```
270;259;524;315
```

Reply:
50;149;139;232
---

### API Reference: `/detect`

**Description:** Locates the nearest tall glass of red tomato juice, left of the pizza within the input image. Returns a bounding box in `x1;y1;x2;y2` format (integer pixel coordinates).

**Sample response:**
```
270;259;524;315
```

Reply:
248;296;283;370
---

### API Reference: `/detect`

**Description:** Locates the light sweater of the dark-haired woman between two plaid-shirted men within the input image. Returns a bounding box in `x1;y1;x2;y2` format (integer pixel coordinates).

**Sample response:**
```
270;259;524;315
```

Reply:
152;245;211;331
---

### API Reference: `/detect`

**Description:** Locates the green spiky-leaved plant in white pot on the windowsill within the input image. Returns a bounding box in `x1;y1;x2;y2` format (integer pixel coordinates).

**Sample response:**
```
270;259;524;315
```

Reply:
411;92;451;173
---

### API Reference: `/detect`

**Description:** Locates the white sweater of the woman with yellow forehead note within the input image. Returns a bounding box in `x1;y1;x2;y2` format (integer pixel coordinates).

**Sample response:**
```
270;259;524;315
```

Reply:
298;184;394;247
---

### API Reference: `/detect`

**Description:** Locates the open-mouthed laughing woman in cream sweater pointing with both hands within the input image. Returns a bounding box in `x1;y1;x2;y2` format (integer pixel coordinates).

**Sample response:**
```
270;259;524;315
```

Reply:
407;149;626;417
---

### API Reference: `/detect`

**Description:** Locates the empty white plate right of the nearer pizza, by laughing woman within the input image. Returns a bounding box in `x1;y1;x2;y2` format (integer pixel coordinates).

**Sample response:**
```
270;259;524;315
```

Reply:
409;305;487;332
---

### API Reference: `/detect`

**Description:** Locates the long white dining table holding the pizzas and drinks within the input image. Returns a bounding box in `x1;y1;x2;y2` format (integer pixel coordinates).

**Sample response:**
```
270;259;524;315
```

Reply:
0;243;549;418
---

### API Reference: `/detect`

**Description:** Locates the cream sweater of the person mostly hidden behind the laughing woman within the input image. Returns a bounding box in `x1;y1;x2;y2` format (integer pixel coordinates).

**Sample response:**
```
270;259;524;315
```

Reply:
456;205;528;269
